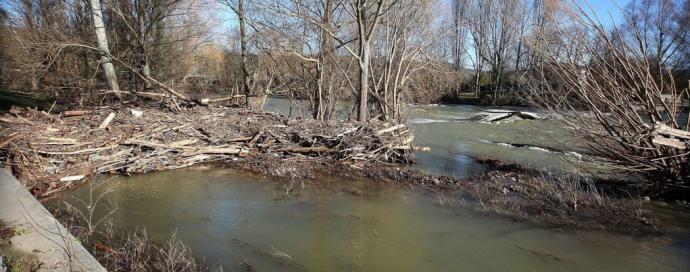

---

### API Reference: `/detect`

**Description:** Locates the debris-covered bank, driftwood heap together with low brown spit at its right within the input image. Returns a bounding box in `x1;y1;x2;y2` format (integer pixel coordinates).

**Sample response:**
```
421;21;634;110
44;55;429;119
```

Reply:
0;105;661;233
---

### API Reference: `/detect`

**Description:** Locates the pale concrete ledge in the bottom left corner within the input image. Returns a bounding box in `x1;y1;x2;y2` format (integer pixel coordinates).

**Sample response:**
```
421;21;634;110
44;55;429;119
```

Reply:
0;169;106;271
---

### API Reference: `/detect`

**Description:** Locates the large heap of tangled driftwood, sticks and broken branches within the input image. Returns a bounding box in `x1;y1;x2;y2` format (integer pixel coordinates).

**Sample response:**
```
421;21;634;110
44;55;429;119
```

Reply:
0;106;414;198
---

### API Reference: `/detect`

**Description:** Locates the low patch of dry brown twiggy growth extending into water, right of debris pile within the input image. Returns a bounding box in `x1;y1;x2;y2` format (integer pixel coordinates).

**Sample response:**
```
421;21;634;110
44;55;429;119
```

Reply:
468;167;661;234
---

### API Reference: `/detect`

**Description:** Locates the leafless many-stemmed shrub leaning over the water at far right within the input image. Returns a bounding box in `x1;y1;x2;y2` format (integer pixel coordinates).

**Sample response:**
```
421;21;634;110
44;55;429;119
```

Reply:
528;1;690;192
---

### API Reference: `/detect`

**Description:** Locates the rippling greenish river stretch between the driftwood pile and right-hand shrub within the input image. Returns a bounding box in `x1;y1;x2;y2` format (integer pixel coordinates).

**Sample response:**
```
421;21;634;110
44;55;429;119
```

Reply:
408;105;592;177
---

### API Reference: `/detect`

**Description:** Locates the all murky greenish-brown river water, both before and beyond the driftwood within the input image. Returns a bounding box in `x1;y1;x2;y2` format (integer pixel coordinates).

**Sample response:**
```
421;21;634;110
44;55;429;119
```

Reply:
50;101;690;271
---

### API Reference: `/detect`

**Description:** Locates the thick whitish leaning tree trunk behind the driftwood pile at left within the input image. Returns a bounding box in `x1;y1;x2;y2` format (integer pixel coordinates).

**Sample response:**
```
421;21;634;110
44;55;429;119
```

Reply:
90;0;120;94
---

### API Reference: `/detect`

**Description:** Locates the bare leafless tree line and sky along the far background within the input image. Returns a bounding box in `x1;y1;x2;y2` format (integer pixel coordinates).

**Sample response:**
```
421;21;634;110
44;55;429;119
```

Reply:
0;0;690;121
